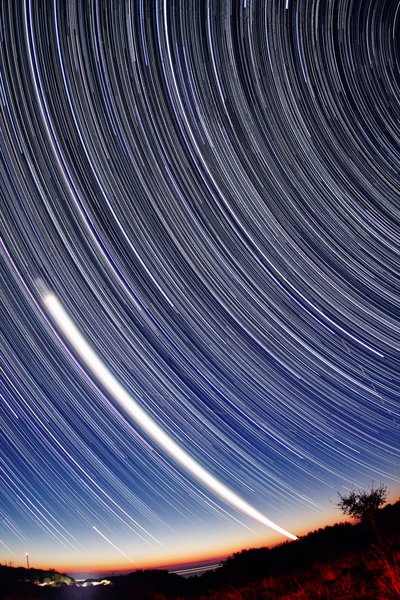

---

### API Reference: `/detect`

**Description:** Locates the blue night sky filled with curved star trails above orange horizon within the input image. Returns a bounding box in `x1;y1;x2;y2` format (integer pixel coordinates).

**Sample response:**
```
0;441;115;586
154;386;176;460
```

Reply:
0;0;400;572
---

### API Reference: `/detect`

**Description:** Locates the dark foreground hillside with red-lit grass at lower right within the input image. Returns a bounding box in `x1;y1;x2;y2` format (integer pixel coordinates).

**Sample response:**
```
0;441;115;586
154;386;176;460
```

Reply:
0;501;400;600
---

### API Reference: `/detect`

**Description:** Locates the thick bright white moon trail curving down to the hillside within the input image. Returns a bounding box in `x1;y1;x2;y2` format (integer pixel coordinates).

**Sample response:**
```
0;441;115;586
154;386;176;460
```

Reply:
44;294;297;540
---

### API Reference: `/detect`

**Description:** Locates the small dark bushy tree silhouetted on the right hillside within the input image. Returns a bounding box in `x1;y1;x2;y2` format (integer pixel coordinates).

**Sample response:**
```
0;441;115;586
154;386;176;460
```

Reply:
336;483;388;529
